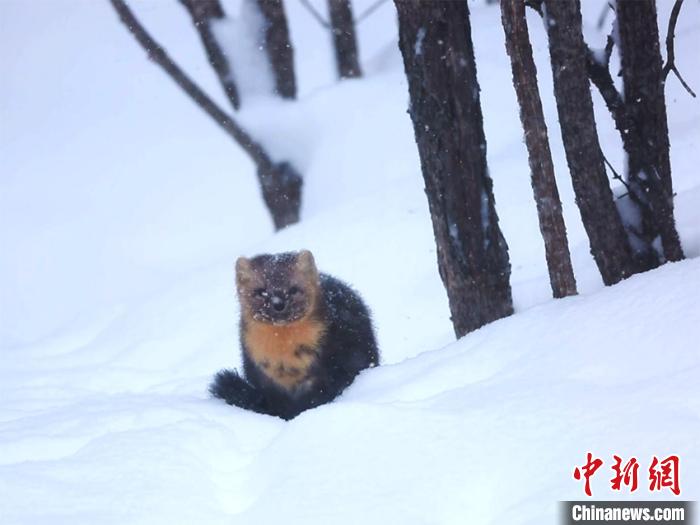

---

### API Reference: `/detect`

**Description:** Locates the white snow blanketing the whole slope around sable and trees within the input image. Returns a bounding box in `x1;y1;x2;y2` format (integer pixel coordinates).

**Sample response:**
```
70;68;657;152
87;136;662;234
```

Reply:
0;0;700;524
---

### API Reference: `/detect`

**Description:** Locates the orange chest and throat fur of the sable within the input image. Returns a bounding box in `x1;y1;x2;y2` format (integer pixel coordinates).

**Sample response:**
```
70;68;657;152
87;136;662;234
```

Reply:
243;319;325;389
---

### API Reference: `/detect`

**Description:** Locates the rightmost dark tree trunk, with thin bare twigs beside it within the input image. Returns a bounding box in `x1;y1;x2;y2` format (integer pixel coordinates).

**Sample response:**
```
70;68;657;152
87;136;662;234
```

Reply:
617;0;683;262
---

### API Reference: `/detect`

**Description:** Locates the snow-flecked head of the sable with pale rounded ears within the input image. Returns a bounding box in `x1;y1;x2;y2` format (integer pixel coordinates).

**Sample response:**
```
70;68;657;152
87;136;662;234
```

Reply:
236;250;319;325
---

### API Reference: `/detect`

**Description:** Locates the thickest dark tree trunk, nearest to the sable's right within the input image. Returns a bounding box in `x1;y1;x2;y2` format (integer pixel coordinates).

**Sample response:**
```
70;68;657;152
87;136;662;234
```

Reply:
395;0;513;337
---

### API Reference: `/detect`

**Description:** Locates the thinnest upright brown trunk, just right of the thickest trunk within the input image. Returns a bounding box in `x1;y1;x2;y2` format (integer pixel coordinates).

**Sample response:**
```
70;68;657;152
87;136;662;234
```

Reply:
501;0;576;297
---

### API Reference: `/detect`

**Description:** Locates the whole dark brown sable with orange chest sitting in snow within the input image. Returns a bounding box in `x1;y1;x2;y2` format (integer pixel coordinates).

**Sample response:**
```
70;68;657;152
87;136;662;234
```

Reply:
211;251;379;419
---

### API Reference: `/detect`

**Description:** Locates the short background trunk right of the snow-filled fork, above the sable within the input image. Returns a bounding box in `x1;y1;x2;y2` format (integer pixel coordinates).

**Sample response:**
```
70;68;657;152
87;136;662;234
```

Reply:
257;0;297;98
